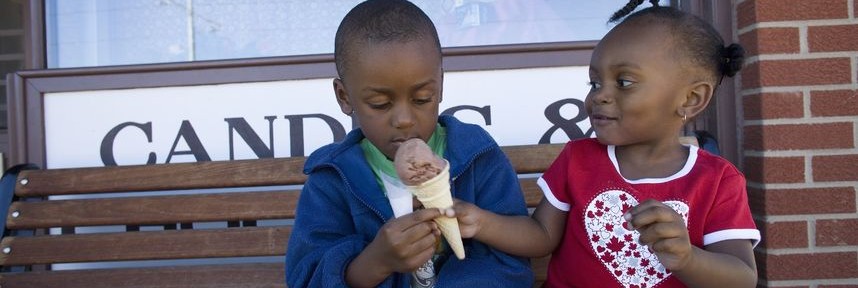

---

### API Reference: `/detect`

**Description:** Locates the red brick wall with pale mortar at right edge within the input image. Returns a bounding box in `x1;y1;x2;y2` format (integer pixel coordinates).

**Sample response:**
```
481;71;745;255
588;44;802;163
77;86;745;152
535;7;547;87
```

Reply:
734;0;858;288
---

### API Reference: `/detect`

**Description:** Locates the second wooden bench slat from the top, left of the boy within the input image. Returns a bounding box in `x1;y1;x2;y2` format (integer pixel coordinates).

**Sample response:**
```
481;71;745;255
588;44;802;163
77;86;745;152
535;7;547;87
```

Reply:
6;190;300;229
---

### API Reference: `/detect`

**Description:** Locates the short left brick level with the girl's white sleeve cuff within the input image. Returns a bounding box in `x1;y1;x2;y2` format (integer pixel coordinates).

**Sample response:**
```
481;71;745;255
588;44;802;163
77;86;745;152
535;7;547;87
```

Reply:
757;221;808;249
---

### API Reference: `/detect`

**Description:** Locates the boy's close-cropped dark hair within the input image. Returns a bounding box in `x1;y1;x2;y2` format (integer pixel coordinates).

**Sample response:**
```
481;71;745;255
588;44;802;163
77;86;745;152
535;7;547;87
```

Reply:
334;0;441;78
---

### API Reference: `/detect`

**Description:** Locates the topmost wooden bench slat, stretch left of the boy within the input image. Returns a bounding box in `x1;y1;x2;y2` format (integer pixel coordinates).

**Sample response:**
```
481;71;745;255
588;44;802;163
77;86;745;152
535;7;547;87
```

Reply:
15;157;307;197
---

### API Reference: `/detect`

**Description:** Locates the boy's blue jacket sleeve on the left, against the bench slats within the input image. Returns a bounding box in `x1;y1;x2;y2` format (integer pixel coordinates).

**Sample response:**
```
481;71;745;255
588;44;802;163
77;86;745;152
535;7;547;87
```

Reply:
286;169;376;287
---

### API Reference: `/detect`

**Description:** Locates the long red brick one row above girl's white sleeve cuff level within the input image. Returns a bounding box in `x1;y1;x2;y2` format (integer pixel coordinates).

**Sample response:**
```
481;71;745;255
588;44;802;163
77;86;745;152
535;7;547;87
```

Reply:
748;187;856;216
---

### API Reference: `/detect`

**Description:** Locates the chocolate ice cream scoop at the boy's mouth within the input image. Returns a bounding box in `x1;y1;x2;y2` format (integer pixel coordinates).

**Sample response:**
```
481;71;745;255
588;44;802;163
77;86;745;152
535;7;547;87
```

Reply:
393;138;447;185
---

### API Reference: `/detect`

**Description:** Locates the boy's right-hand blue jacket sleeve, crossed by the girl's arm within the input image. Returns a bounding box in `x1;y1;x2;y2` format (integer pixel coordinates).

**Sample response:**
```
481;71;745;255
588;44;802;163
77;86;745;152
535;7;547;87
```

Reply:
438;147;533;288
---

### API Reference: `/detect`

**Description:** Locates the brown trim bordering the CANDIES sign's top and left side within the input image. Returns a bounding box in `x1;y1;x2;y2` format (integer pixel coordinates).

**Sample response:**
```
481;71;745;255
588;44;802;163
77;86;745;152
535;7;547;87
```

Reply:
8;41;597;167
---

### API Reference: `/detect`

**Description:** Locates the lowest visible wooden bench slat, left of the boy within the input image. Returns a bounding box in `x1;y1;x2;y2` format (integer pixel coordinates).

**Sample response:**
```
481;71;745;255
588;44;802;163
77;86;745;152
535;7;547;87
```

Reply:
0;263;286;288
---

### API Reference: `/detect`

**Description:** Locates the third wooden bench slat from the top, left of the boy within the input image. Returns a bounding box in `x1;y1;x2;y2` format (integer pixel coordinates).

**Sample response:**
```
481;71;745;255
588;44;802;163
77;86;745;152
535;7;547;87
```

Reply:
0;226;292;266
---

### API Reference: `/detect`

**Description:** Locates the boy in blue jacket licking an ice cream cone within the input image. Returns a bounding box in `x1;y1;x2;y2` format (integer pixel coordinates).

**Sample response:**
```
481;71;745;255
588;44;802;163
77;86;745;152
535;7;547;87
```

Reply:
286;0;533;287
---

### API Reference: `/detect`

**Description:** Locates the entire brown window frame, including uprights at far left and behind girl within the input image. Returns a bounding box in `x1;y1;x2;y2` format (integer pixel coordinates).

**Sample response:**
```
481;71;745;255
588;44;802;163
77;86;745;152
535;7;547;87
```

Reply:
7;0;741;166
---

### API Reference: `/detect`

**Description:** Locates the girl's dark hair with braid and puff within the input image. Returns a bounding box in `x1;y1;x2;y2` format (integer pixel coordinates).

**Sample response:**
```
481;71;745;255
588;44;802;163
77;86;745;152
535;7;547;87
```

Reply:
609;0;745;85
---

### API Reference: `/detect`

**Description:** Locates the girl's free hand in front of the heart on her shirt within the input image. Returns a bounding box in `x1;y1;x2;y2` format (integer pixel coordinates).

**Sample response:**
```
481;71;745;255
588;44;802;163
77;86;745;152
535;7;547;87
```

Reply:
623;199;694;271
